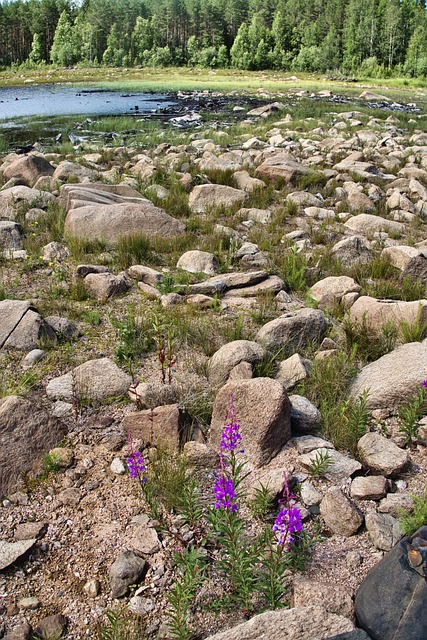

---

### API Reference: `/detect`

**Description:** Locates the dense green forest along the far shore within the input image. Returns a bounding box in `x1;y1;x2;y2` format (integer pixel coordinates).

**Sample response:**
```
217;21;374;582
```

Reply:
0;0;427;77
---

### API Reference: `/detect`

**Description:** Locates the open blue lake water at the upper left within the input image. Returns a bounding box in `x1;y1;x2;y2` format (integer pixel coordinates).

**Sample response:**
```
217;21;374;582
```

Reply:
0;85;177;120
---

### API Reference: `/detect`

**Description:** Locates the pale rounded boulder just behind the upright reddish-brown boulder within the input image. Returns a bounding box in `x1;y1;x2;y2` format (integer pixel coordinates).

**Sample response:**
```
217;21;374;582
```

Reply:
209;340;264;386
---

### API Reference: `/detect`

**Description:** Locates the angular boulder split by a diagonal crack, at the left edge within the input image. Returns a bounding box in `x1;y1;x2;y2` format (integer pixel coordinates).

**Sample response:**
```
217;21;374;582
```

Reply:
0;300;56;351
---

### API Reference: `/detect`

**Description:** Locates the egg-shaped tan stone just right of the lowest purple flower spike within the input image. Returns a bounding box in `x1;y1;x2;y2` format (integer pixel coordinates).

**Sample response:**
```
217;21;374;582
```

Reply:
320;487;363;537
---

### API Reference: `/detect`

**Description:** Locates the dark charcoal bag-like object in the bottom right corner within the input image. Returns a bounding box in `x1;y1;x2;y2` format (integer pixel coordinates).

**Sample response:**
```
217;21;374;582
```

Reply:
355;526;427;640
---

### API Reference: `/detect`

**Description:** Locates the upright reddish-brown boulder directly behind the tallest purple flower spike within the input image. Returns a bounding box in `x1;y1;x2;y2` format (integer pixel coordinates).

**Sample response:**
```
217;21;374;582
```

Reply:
209;378;291;467
